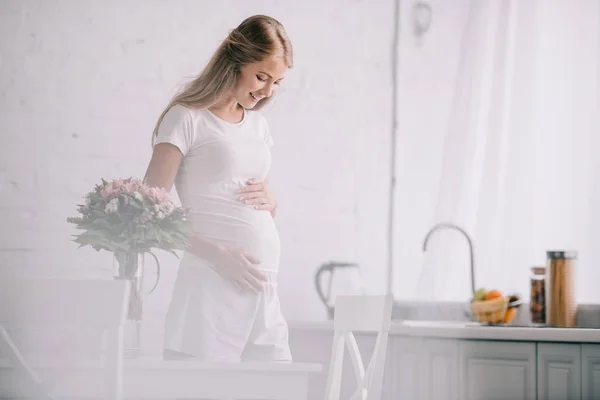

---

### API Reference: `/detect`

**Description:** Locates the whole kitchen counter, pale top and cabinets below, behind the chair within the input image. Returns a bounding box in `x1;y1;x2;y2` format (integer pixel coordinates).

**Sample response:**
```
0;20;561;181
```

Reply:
289;313;600;400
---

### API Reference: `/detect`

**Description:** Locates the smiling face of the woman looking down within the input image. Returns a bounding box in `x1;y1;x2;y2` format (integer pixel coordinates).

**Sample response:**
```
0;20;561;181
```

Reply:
234;56;287;109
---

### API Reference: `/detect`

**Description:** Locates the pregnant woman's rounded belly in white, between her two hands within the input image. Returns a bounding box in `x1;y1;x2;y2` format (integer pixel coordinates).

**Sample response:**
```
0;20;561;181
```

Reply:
191;202;280;270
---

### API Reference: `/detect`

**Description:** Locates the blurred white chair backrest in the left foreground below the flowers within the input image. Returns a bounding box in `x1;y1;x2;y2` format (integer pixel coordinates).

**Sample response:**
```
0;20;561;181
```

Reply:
0;279;130;399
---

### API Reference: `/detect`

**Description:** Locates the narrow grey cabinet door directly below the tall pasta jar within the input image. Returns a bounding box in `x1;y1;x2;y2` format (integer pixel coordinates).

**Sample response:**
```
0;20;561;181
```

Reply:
537;343;581;400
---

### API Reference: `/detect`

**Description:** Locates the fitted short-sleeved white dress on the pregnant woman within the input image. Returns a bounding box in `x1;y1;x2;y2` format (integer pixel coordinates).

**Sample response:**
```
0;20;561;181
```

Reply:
155;105;291;361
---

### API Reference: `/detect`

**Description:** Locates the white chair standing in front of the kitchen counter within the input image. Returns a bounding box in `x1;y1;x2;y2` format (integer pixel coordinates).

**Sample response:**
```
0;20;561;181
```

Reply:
325;294;393;400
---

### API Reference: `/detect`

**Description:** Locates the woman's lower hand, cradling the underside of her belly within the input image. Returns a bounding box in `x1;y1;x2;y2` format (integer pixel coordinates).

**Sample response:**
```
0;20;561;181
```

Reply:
213;245;267;293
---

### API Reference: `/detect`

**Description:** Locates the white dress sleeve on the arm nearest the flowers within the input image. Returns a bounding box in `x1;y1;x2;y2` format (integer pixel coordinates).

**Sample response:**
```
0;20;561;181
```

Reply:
154;104;195;155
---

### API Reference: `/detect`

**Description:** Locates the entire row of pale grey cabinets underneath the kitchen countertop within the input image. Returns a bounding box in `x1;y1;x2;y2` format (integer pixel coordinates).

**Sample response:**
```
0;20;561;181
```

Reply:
290;328;600;400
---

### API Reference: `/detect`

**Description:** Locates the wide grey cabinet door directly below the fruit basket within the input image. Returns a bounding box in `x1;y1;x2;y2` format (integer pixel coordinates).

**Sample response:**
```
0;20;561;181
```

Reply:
459;340;536;400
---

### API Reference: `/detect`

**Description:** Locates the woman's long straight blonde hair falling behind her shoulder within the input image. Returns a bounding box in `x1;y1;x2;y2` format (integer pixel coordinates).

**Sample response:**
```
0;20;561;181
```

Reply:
152;15;293;145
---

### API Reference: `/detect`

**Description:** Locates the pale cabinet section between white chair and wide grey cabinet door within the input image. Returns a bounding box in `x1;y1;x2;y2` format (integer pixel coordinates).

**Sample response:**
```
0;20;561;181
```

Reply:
391;337;458;400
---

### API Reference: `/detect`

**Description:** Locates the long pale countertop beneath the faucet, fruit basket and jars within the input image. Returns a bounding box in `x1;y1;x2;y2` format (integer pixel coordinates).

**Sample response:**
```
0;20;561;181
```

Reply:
288;320;600;343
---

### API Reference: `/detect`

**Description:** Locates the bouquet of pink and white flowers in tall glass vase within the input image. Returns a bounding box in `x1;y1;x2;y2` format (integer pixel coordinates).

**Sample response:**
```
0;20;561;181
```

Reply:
67;178;192;355
